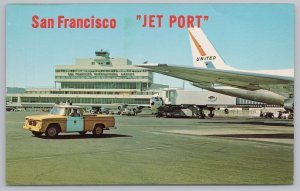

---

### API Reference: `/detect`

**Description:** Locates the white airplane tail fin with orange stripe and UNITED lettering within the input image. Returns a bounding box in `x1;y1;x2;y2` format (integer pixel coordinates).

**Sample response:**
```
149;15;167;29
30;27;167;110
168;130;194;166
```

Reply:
188;27;235;70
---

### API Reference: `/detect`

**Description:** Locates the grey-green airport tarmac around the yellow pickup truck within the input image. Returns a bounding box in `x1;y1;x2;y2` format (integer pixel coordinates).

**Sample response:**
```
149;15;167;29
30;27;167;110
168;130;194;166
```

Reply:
6;112;294;185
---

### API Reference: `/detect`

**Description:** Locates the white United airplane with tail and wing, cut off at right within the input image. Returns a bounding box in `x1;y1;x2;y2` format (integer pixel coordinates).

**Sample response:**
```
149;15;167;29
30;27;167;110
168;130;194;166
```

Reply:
137;28;294;113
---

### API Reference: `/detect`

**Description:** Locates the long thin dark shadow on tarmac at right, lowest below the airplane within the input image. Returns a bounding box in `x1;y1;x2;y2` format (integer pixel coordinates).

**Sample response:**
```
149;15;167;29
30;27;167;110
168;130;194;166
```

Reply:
207;133;294;139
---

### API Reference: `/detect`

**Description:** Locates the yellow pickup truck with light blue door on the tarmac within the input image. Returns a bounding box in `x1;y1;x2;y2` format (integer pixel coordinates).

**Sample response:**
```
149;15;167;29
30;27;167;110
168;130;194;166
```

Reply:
23;104;116;138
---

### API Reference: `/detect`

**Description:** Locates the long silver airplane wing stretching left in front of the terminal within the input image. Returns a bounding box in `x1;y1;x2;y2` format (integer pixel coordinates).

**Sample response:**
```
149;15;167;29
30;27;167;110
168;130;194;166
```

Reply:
137;64;294;97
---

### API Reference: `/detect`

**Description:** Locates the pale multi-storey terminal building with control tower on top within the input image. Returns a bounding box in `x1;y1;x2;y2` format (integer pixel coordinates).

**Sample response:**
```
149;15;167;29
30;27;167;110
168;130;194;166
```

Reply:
6;51;168;107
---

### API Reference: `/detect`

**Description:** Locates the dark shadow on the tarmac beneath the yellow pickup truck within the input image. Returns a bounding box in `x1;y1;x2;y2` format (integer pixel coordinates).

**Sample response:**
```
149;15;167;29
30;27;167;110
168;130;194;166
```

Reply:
33;134;132;140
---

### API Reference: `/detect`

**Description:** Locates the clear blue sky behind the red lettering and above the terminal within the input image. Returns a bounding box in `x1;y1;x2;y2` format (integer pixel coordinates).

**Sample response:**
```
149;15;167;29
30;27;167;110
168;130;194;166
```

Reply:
6;4;294;89
